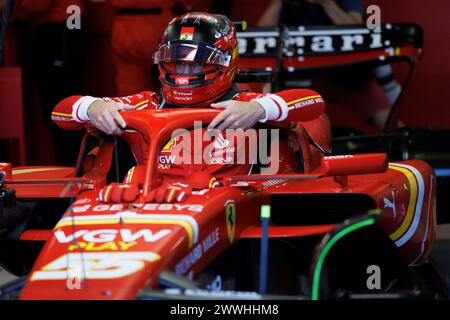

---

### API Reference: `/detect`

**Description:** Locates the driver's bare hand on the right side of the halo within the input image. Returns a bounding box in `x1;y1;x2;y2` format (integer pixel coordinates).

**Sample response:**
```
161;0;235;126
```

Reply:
208;100;266;131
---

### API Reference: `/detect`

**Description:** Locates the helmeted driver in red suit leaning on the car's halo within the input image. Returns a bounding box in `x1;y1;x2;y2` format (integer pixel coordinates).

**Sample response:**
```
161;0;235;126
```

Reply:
52;13;325;202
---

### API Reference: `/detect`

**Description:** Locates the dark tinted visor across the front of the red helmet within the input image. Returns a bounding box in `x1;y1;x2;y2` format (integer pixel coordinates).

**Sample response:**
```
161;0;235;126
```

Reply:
153;40;231;67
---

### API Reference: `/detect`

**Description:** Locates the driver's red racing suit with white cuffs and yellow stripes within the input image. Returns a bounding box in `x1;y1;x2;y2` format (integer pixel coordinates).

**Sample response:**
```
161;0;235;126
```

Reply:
52;89;325;182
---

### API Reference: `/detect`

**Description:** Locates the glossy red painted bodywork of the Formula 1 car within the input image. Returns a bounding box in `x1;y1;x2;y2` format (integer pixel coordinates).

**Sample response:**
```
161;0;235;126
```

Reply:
1;109;436;299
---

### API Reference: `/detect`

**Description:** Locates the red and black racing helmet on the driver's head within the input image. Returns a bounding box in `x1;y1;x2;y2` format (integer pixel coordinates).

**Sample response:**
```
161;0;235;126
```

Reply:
153;12;239;107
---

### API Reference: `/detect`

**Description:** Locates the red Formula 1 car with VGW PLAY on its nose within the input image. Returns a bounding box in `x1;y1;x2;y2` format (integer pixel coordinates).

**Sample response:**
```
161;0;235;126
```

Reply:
0;108;445;299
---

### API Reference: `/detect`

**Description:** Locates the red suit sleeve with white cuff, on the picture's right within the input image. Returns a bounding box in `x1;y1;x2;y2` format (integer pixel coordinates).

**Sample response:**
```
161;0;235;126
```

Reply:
236;89;325;122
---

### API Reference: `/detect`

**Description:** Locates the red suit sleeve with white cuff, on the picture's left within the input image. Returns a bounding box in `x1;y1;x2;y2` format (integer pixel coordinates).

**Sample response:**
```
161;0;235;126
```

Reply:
52;91;158;130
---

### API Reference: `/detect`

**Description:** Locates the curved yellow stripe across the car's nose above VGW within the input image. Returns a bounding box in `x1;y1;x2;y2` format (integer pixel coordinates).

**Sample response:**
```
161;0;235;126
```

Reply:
53;217;194;248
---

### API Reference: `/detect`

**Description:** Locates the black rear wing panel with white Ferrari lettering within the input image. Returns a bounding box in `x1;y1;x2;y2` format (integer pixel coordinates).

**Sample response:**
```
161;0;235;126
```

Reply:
238;24;422;57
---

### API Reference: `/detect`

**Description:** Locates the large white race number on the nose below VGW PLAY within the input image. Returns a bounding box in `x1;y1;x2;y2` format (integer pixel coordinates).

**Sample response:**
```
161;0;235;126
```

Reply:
31;252;161;281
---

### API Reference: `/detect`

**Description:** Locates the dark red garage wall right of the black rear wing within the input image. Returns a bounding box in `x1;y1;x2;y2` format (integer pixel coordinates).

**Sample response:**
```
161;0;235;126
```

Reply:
366;0;450;128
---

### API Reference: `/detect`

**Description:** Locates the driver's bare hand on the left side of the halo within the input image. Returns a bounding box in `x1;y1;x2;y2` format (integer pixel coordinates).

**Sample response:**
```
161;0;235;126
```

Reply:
87;100;127;134
